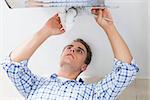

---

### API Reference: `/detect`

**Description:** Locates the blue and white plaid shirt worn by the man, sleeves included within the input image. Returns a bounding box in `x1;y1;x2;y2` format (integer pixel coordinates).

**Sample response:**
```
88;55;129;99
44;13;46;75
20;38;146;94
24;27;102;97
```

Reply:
1;57;138;100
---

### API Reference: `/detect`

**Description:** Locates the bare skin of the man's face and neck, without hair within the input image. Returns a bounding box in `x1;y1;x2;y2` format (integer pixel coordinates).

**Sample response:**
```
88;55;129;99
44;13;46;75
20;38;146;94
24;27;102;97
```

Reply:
58;42;87;79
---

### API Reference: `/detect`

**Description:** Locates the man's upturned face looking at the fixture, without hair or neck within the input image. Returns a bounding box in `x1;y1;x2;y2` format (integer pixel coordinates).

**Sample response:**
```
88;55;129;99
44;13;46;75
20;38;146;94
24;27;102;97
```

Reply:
60;42;87;71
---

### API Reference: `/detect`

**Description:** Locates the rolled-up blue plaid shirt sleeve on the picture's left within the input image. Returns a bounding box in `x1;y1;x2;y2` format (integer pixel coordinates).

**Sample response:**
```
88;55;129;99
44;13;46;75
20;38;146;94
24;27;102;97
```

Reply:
1;57;38;98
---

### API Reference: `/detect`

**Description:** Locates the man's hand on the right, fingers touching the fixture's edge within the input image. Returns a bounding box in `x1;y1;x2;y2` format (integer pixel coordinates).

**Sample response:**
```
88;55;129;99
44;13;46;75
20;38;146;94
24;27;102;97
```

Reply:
91;7;113;31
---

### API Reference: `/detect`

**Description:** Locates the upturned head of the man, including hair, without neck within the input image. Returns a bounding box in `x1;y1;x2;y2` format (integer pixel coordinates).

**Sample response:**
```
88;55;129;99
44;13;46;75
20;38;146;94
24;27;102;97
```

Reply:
60;39;92;73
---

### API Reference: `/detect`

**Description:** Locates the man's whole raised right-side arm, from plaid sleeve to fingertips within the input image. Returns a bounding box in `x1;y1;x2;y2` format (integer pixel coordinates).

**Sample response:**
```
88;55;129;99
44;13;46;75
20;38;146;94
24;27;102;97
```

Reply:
92;8;139;100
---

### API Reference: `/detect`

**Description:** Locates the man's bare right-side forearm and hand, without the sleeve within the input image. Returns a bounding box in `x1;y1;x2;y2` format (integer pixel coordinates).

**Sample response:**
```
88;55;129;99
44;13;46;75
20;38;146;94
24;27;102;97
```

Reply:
92;8;132;63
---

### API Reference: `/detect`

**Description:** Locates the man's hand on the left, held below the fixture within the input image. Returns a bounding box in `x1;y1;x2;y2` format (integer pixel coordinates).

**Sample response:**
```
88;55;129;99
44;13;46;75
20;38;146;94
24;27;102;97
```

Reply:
40;14;65;36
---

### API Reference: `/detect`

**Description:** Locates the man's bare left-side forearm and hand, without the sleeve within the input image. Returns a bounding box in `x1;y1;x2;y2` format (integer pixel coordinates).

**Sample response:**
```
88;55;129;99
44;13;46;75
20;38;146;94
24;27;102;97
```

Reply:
10;14;64;62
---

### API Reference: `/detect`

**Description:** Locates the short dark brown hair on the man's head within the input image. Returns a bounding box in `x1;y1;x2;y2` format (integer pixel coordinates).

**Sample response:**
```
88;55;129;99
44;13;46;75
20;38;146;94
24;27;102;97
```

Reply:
73;38;92;65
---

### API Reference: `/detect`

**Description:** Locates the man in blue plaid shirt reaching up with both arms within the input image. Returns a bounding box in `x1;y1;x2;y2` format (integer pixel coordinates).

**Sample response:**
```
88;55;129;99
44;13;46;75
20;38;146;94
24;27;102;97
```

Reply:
0;8;138;100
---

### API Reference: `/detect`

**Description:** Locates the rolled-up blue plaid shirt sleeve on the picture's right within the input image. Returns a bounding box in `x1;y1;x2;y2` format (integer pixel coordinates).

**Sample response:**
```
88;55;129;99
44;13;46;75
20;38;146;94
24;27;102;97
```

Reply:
94;58;139;100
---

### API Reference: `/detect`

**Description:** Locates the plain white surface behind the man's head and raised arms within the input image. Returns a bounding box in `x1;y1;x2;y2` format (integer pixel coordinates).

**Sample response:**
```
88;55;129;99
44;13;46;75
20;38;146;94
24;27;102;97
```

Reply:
2;0;150;77
